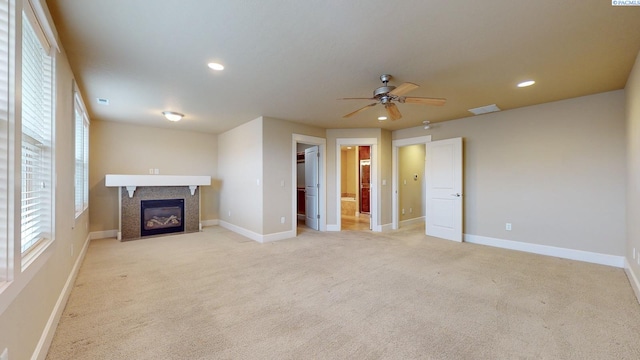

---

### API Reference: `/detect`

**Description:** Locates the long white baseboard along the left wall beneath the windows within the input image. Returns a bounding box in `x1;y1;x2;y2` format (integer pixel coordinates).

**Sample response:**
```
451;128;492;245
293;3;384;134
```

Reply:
31;234;91;360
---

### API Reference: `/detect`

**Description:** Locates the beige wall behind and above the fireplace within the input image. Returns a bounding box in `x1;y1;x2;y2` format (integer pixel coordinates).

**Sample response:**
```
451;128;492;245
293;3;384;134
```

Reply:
89;121;219;231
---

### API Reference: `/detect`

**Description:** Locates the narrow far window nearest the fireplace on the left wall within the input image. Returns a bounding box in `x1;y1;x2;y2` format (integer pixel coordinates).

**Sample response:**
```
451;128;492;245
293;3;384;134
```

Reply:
73;84;89;217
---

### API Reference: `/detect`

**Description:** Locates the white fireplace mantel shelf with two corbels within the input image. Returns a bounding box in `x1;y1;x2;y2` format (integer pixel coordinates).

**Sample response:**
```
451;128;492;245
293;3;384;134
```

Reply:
104;174;211;197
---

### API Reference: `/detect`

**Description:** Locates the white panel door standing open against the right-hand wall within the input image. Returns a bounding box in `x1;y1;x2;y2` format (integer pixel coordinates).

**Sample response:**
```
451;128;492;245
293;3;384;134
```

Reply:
425;138;462;242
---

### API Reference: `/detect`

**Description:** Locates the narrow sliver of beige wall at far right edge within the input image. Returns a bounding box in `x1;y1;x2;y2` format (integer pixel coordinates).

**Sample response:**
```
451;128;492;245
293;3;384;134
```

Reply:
624;53;640;300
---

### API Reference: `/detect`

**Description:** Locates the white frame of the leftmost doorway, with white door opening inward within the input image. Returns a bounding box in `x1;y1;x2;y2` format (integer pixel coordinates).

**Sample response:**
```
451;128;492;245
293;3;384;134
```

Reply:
291;133;327;236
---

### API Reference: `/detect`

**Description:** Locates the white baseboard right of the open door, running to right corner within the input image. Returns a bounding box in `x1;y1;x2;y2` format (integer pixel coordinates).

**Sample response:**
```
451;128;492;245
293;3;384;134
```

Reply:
464;234;625;268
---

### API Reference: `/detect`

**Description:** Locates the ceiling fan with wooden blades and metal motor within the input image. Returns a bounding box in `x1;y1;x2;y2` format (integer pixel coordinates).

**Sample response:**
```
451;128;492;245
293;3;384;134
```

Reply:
339;74;447;120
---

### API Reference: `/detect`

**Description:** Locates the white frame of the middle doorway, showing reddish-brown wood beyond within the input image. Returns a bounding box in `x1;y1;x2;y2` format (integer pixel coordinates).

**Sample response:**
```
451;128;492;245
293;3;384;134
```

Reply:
336;138;382;232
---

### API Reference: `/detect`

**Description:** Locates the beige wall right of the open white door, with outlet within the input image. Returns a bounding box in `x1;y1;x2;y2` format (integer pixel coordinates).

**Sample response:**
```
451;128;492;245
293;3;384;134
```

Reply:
394;90;626;255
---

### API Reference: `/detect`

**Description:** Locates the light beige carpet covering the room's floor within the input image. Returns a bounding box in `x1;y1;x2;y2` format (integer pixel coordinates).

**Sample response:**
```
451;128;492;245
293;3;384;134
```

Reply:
47;225;640;360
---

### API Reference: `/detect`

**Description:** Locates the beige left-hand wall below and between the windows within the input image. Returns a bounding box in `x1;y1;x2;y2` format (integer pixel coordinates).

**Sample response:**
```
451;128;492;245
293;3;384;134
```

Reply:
0;17;88;359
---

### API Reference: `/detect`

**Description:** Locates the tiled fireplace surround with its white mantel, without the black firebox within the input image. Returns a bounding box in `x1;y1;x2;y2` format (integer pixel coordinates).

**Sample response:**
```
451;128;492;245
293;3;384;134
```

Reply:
105;175;211;241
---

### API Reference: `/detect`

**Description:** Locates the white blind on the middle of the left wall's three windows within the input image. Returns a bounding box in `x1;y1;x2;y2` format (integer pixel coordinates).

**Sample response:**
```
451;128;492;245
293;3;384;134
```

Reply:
21;9;53;255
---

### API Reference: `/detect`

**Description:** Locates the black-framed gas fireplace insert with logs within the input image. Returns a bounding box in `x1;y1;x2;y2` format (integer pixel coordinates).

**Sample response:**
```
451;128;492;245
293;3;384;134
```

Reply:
140;199;184;236
